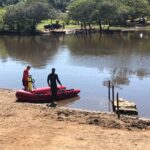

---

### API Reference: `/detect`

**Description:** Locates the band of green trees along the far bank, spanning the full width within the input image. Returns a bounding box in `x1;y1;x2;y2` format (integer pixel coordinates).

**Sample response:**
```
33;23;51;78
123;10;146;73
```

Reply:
0;0;150;32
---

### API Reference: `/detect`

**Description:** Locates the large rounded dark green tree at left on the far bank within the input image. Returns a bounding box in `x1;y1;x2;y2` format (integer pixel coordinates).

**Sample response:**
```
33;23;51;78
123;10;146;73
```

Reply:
5;1;54;33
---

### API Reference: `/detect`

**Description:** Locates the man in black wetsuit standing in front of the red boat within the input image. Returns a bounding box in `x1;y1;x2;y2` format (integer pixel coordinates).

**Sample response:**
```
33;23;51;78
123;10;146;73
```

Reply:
47;68;62;107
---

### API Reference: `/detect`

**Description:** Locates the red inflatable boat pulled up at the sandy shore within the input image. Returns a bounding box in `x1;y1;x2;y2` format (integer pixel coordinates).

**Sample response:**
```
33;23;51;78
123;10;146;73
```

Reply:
16;86;80;103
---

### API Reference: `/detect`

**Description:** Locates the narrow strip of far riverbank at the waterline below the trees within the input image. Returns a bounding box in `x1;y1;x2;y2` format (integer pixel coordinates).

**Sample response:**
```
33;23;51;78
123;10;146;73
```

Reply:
0;26;150;36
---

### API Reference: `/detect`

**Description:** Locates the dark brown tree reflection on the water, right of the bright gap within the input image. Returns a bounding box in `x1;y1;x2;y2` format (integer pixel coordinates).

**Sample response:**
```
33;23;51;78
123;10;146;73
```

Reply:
68;33;149;56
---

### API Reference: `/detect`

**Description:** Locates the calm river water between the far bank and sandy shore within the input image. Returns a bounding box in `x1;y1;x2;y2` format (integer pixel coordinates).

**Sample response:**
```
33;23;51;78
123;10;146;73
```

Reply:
0;32;150;117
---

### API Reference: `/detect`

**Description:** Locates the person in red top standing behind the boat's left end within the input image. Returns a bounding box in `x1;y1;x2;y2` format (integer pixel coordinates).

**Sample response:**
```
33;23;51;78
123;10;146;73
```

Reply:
22;66;31;90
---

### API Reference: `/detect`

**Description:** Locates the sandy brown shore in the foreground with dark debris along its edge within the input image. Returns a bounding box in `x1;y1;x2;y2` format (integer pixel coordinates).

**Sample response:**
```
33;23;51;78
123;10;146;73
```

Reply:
0;89;150;150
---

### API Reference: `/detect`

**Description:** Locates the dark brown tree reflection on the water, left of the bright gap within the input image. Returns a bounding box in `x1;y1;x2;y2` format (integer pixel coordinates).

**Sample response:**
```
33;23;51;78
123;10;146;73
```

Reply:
0;36;65;68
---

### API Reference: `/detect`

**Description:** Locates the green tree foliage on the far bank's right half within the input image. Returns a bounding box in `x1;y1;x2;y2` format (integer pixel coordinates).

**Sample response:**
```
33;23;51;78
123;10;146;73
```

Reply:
68;0;150;29
